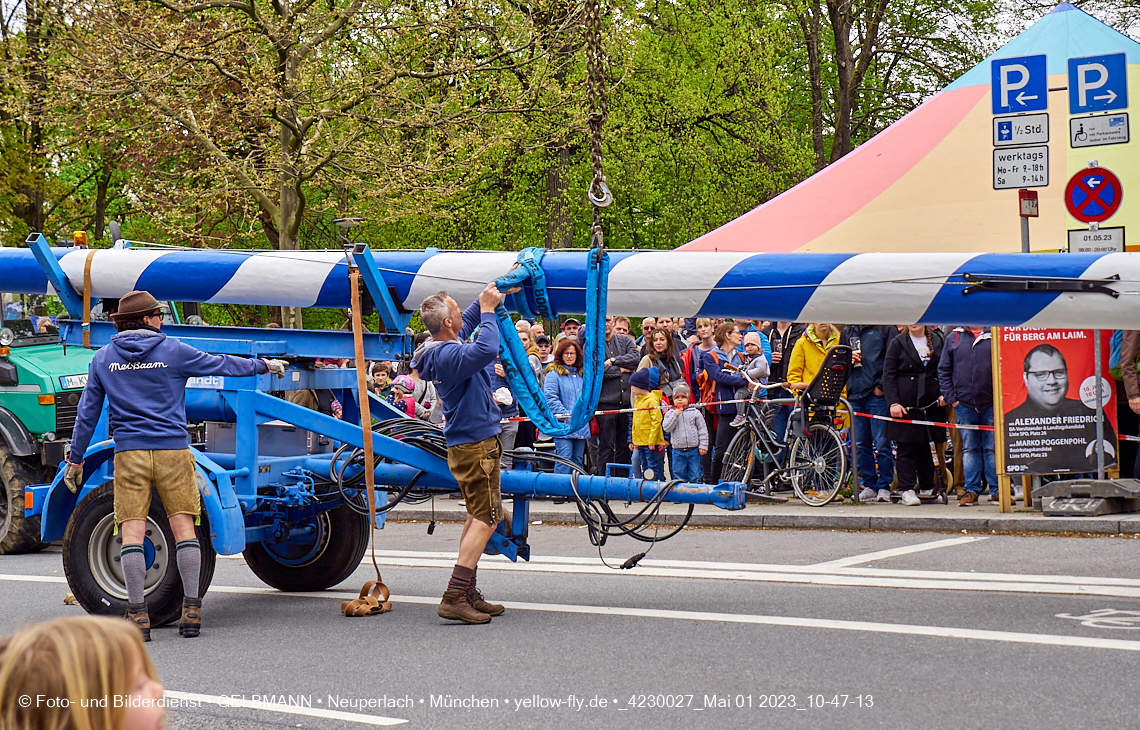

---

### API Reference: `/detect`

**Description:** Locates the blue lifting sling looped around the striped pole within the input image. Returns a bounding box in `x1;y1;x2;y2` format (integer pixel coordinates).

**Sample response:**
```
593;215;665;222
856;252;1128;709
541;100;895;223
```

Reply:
495;248;610;438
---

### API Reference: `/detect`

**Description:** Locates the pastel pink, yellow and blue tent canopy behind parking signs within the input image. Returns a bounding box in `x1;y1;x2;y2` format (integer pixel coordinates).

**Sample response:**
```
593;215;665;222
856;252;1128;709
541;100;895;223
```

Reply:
681;3;1140;252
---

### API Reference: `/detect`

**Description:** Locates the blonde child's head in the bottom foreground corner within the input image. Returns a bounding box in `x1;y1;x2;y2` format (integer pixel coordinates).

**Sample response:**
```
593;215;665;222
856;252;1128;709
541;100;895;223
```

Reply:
0;616;165;730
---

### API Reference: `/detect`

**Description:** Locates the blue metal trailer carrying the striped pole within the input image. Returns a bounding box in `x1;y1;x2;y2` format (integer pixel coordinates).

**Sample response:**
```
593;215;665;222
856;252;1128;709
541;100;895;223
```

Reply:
25;234;744;625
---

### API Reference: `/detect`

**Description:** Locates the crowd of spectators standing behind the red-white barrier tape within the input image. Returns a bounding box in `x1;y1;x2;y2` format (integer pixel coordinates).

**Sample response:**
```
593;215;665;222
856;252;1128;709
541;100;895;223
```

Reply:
339;316;1140;506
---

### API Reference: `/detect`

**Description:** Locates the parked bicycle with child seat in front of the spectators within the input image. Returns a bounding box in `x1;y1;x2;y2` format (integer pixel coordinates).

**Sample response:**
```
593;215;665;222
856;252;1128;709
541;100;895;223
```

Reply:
720;344;852;506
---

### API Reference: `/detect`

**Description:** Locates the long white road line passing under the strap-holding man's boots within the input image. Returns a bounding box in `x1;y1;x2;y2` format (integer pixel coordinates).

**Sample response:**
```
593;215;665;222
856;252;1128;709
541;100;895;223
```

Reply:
8;575;1140;651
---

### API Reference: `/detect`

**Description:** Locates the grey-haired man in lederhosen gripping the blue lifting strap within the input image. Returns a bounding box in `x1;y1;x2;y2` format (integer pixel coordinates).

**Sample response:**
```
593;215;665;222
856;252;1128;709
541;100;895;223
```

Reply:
412;283;519;624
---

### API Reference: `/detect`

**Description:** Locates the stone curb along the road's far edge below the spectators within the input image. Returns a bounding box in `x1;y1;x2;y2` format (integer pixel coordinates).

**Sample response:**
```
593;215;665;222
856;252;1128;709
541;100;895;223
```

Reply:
390;508;1140;535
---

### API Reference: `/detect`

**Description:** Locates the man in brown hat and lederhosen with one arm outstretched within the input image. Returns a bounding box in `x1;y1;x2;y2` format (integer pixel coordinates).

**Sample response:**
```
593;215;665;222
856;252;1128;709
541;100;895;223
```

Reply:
64;291;285;641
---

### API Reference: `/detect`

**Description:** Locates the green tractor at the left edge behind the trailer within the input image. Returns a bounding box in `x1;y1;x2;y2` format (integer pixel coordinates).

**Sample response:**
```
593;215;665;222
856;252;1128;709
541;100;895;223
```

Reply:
0;297;95;554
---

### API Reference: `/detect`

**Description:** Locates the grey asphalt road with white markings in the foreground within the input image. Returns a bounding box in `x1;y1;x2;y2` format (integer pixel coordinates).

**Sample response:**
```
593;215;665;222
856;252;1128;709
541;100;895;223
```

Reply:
0;524;1140;730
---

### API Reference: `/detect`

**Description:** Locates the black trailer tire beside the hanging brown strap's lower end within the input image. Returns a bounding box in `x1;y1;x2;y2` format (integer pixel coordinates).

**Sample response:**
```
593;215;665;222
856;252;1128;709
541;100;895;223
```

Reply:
243;504;368;593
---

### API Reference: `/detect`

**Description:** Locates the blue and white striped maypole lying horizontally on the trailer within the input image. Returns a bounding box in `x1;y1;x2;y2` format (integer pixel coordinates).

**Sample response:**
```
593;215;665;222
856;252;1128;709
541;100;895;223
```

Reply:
0;248;1140;330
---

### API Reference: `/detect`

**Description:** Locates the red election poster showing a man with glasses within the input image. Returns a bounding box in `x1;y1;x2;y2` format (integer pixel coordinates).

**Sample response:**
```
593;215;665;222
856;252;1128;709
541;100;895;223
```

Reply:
995;327;1117;475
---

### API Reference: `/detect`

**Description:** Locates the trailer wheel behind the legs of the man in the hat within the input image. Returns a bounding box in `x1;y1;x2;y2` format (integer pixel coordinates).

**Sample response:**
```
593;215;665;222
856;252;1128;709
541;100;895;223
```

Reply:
64;481;217;626
